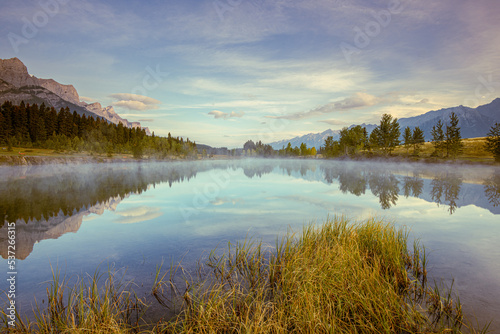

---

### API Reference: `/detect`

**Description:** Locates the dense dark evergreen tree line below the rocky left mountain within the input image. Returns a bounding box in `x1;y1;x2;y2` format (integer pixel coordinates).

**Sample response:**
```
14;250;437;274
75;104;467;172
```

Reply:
0;101;196;158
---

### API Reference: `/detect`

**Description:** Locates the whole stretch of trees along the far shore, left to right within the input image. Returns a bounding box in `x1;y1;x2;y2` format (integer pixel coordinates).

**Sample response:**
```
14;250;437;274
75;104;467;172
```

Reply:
0;101;500;161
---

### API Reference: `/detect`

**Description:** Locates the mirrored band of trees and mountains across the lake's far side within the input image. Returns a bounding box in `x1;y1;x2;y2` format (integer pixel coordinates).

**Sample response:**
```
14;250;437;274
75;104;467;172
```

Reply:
0;160;500;259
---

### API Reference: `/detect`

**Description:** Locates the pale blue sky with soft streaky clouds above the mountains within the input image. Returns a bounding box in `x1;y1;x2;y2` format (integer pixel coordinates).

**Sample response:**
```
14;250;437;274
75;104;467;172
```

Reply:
0;0;500;148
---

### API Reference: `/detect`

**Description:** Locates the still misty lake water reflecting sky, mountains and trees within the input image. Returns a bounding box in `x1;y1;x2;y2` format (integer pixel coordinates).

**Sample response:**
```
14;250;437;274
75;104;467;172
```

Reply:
0;160;500;332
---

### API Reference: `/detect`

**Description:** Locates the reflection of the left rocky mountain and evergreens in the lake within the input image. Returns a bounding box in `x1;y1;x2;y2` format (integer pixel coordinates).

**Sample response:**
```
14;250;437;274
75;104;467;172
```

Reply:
0;163;224;260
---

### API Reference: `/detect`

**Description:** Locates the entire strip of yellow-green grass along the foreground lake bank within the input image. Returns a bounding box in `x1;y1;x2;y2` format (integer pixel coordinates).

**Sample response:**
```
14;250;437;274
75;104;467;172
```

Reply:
1;218;492;333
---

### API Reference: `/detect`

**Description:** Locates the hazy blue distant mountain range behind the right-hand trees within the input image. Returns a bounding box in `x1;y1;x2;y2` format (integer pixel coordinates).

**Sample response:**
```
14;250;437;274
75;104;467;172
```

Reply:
270;98;500;149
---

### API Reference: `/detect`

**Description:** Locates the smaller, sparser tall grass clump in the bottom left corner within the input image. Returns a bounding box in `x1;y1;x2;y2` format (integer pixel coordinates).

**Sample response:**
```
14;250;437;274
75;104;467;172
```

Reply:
0;269;146;333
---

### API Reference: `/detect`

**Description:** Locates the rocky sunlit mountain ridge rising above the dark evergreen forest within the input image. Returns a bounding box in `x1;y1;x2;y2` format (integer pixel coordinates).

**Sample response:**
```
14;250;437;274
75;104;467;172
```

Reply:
0;58;150;134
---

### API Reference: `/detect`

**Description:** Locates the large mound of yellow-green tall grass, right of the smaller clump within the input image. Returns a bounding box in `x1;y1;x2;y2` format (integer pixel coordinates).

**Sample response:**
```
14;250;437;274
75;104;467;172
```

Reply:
155;219;488;333
